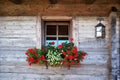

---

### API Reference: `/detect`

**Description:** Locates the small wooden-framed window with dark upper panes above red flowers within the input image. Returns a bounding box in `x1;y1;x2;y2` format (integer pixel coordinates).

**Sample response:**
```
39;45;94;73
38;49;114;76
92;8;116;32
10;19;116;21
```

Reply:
44;21;70;46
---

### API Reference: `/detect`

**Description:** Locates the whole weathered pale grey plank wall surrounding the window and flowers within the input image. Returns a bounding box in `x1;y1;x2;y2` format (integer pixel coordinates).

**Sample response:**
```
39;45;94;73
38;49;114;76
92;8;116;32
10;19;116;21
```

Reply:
0;16;110;80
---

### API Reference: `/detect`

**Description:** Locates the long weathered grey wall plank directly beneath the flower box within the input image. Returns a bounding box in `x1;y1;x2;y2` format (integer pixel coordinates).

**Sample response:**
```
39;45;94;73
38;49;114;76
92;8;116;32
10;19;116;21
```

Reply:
0;63;108;77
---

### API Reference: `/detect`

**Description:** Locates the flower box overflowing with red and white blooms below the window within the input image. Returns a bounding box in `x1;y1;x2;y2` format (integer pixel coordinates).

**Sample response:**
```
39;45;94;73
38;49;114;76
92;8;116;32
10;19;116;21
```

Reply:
25;38;87;69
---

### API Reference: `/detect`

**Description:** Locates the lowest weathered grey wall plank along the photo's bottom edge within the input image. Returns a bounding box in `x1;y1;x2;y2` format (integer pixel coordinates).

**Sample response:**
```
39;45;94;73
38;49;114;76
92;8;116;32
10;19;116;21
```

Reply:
0;73;108;80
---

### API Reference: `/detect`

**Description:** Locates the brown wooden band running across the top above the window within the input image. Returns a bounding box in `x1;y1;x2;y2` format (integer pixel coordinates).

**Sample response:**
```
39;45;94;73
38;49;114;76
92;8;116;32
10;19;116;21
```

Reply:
0;0;120;16
